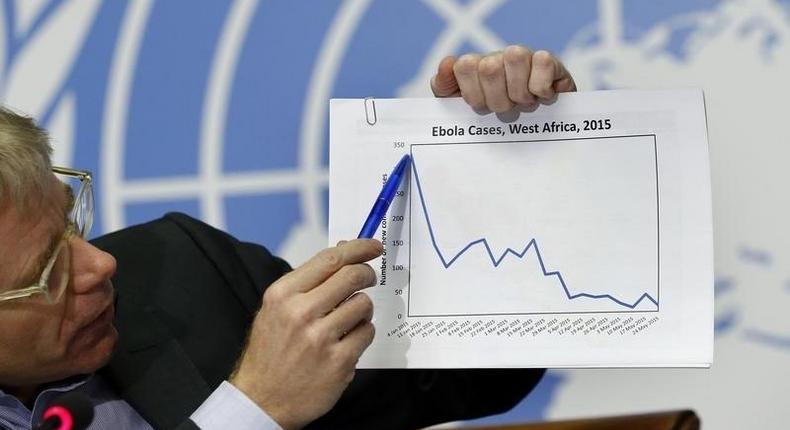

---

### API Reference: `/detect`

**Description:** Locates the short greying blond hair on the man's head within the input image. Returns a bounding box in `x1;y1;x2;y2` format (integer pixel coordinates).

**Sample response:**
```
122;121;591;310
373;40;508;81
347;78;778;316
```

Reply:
0;106;52;213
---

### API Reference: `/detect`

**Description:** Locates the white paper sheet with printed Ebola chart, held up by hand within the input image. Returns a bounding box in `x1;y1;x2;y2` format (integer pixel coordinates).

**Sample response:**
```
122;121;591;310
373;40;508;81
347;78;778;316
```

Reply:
329;90;713;368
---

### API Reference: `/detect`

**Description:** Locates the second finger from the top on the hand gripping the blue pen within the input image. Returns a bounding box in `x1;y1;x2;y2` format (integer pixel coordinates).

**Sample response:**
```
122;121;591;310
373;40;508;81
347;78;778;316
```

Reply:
305;264;376;315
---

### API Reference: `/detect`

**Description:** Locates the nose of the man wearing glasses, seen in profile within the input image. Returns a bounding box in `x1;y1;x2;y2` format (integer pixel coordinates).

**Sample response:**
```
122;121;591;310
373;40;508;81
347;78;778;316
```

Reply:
70;238;117;294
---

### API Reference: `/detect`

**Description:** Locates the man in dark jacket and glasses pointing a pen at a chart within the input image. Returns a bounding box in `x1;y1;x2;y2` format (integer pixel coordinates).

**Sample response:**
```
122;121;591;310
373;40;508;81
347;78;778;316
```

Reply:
0;46;575;430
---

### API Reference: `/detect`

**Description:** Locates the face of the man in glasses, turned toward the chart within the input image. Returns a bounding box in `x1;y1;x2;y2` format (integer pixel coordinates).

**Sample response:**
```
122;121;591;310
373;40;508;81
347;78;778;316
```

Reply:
0;175;118;387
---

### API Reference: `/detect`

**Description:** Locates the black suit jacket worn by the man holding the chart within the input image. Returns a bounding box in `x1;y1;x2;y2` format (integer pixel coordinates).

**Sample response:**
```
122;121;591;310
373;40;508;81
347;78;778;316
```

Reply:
94;213;543;429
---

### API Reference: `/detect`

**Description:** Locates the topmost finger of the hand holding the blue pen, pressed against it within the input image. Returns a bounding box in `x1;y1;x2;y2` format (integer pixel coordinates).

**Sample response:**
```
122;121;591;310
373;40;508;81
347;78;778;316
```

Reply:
278;239;384;292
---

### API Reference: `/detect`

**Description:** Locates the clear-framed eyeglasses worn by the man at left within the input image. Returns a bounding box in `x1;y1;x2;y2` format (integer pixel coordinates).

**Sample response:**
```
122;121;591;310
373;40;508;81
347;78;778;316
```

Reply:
0;166;93;304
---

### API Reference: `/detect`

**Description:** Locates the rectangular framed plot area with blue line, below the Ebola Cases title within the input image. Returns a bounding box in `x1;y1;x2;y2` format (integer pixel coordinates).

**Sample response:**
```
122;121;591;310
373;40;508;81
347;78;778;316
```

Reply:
408;135;660;317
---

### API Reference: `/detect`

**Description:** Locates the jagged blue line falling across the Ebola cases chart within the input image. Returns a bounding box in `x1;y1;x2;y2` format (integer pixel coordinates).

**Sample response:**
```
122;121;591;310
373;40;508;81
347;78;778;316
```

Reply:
411;154;658;309
